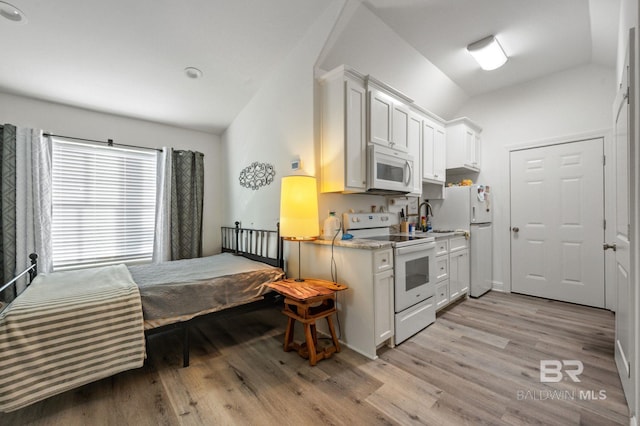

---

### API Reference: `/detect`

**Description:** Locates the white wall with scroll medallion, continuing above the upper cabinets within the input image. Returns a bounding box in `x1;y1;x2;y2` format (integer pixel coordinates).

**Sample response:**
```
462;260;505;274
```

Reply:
222;0;456;240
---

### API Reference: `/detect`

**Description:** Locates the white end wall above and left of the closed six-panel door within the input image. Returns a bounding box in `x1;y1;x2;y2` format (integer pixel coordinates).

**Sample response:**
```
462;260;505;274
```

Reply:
458;65;616;291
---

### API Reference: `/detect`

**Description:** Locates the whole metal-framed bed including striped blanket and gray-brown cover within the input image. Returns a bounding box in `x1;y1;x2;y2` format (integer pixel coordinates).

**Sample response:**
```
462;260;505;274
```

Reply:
0;222;284;412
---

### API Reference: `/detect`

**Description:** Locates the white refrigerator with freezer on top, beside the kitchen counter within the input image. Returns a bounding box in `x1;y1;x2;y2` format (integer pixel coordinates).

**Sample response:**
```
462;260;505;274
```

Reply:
431;185;493;297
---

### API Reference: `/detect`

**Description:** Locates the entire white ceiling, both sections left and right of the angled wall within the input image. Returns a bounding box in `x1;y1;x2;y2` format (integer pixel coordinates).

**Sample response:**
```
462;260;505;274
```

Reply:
0;0;619;133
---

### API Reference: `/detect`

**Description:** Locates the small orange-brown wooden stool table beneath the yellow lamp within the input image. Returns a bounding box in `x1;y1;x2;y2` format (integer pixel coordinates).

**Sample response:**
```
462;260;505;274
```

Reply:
267;279;347;365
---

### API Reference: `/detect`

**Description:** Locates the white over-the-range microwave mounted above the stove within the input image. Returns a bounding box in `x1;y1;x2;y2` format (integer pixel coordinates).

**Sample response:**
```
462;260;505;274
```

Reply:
367;144;415;195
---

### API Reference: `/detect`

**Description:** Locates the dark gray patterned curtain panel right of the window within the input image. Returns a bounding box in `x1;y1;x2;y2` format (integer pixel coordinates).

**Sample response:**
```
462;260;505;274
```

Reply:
171;150;204;260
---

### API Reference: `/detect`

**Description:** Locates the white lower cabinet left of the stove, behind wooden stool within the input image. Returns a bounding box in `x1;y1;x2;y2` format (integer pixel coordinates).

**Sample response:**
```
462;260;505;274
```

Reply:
294;241;394;359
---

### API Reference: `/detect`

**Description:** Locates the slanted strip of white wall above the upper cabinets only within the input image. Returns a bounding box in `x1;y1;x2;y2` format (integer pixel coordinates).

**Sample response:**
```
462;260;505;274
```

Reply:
318;5;469;120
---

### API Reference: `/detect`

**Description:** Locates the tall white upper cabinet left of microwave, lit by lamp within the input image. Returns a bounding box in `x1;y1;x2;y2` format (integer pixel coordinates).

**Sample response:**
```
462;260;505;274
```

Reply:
319;67;367;193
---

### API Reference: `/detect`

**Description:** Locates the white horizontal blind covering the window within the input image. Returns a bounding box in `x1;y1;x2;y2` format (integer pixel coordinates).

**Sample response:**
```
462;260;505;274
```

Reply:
51;139;157;270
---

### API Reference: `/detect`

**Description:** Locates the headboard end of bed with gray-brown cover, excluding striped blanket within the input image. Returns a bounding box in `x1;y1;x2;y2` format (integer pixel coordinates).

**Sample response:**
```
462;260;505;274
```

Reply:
136;222;285;367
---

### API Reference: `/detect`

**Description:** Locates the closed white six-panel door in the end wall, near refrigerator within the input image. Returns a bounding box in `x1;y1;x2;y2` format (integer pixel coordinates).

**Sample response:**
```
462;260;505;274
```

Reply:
510;138;605;307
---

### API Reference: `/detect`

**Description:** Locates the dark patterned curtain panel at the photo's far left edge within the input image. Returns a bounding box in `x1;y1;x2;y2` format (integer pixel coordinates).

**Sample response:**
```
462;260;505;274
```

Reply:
0;124;16;302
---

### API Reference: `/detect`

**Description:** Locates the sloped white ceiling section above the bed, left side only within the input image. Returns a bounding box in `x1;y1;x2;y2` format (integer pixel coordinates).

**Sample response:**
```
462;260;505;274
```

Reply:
0;0;328;133
